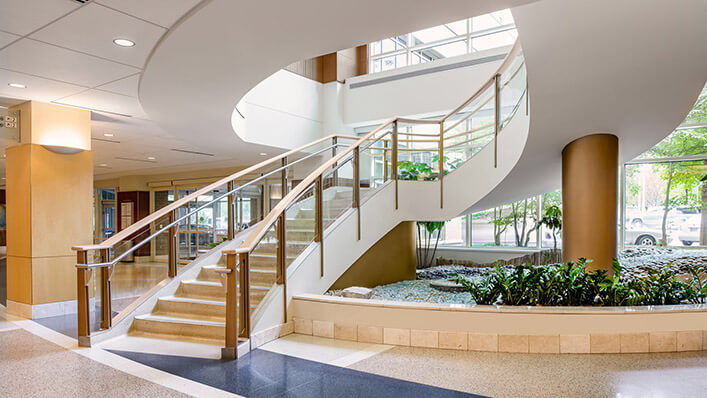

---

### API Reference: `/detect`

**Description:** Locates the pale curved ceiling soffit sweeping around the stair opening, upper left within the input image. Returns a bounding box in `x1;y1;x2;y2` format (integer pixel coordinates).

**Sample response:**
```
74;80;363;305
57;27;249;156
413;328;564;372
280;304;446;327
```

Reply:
139;0;532;163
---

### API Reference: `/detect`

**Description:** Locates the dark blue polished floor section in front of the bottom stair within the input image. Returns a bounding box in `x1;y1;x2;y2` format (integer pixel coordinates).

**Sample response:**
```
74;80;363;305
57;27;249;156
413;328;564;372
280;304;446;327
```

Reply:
111;350;481;398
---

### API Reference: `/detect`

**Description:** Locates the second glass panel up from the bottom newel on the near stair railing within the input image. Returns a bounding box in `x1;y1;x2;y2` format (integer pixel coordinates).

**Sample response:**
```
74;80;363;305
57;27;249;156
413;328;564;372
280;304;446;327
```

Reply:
285;185;316;266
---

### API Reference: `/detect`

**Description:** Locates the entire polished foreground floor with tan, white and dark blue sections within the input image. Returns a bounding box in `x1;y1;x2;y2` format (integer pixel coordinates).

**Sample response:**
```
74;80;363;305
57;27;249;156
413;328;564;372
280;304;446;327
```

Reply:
0;306;707;398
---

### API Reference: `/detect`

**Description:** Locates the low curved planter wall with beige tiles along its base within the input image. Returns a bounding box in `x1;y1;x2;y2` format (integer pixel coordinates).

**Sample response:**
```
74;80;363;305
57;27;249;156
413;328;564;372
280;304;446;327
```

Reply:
293;296;707;354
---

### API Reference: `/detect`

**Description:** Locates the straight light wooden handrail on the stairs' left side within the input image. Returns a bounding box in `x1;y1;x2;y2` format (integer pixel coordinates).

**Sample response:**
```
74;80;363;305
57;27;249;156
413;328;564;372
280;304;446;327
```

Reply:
71;134;358;251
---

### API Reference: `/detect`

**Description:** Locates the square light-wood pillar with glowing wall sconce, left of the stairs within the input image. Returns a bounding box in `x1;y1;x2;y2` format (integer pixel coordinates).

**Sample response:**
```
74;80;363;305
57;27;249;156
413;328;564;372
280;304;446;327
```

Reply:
6;102;93;305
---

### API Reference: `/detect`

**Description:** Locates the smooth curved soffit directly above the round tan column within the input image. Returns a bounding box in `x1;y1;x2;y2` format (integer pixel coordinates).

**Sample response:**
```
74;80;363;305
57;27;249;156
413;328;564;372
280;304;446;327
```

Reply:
469;0;707;211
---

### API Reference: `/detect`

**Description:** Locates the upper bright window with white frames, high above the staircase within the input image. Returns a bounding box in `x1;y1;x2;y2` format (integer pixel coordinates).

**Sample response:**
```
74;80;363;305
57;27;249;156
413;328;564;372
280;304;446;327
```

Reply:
368;10;517;73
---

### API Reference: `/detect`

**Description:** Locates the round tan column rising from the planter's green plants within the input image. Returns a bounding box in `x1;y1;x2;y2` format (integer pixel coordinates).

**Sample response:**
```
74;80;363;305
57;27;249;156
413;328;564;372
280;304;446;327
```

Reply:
562;134;619;272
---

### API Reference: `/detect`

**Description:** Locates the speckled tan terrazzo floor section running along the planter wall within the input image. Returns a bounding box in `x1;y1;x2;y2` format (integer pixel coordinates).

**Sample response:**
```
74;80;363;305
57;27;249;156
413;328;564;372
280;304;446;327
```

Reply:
349;347;707;397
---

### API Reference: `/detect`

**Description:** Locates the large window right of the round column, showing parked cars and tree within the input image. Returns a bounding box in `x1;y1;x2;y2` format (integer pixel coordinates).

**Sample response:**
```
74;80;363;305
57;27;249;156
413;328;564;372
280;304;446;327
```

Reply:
620;87;707;246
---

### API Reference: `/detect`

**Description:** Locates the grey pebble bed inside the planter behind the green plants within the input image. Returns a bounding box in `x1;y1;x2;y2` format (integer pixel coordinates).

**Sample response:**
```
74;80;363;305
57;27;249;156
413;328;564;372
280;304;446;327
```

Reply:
326;248;707;304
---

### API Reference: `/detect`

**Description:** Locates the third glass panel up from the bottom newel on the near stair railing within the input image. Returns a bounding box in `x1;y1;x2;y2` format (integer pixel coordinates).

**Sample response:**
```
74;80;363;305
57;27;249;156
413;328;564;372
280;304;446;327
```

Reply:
322;157;354;231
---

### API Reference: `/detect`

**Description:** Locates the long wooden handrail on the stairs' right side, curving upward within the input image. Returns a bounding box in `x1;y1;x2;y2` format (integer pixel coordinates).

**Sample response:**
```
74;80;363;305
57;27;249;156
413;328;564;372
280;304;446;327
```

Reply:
235;40;520;254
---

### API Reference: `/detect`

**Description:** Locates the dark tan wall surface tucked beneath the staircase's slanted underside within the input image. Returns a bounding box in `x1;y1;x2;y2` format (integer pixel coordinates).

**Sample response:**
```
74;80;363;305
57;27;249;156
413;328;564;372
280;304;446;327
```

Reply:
331;221;417;289
